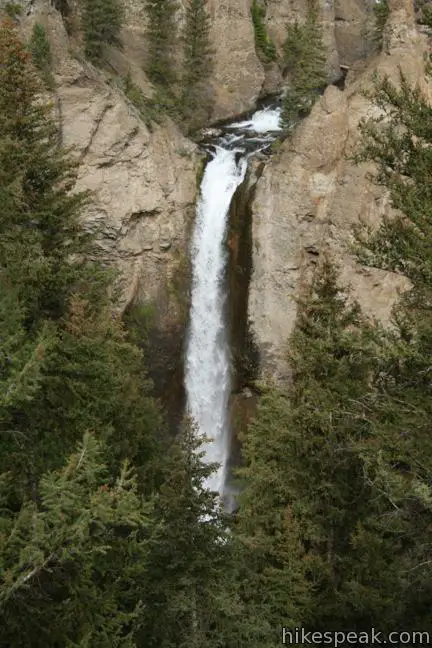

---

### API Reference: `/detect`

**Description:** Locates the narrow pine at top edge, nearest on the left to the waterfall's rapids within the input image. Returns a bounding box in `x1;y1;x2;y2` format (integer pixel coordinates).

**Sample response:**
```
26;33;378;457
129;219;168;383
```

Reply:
181;0;213;128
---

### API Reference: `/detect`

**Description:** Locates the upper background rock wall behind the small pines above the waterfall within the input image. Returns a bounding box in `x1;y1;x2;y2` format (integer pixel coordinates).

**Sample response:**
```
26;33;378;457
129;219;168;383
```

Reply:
6;0;384;125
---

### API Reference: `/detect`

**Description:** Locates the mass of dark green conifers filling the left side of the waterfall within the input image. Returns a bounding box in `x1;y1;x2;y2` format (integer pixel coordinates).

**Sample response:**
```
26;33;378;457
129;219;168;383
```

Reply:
0;22;236;648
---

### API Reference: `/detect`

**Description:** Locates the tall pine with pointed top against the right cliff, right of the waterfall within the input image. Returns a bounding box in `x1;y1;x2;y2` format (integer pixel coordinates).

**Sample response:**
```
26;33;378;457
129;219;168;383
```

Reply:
239;261;384;632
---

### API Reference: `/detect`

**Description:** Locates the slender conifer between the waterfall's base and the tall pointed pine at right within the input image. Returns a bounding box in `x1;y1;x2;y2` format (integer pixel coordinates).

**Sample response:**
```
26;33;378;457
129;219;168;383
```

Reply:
233;389;311;648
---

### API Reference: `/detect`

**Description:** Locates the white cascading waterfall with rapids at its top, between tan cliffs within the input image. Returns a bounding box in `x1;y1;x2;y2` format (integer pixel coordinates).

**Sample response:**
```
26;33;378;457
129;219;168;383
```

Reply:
185;109;280;496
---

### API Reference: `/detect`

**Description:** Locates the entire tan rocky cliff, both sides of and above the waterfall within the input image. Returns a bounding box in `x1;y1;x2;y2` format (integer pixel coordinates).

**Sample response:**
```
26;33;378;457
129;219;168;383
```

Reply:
0;0;427;390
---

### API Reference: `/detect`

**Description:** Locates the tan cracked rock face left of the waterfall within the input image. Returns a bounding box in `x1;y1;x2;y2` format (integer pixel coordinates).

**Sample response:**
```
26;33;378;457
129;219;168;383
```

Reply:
16;1;199;324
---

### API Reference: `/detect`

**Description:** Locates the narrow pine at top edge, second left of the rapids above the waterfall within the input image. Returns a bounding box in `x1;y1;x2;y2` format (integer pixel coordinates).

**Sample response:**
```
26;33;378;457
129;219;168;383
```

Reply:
145;0;177;91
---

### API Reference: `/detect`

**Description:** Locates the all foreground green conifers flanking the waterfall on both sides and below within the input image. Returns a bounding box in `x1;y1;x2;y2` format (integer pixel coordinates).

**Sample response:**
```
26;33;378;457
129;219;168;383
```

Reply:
0;5;432;648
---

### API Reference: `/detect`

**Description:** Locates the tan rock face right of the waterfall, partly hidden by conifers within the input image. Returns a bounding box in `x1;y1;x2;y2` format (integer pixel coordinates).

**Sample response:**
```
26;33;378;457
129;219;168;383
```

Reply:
248;0;429;378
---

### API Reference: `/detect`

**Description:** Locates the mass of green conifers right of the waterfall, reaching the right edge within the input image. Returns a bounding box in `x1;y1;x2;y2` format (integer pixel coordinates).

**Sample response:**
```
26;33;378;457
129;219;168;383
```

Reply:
237;68;432;633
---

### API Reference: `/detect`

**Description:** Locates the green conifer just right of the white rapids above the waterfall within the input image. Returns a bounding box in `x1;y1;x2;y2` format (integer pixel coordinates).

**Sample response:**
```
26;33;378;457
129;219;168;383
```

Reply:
282;0;327;129
